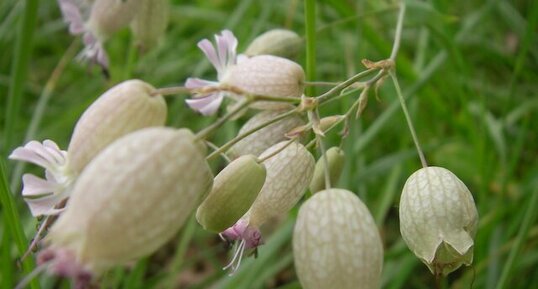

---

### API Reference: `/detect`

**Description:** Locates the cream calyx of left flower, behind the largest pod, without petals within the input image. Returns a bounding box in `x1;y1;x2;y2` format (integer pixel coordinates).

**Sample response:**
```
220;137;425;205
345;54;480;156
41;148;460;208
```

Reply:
67;80;167;173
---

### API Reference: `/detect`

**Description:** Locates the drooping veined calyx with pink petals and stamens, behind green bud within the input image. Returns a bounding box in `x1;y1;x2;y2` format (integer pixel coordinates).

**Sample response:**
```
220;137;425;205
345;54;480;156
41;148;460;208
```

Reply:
221;141;315;271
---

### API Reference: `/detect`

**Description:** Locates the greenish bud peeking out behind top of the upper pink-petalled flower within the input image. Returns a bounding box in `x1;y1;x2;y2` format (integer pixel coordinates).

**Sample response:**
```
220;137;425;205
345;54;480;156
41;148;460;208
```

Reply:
245;29;303;59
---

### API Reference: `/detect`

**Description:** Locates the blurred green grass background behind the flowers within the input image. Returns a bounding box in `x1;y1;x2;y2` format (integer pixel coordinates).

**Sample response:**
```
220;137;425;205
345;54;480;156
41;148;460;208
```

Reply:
0;0;538;289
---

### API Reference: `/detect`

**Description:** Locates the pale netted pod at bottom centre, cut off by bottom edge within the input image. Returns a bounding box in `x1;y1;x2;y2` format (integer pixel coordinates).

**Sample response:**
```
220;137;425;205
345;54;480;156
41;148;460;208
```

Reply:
293;189;383;289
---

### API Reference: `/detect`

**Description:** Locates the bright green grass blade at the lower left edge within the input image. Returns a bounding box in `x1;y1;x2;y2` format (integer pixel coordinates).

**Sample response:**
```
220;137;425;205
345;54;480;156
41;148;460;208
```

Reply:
0;159;39;289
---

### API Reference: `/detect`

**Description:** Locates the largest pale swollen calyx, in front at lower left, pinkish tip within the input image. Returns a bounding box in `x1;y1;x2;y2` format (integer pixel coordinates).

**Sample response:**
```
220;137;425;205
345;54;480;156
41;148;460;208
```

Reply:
43;127;213;277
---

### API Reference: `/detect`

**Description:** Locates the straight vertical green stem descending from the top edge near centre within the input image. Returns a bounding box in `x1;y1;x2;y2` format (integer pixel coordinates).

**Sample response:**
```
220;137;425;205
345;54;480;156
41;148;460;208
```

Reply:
304;0;316;96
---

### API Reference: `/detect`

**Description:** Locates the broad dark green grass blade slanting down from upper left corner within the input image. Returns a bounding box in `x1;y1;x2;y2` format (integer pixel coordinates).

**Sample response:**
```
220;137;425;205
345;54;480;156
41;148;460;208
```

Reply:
4;0;39;154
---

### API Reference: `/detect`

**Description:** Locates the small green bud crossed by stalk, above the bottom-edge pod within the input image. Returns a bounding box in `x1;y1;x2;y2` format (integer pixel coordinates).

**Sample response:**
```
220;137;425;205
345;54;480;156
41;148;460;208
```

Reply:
309;147;344;193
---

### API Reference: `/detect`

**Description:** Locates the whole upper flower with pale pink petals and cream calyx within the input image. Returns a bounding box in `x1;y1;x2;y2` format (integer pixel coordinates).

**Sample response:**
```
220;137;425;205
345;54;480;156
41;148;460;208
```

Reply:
185;30;304;115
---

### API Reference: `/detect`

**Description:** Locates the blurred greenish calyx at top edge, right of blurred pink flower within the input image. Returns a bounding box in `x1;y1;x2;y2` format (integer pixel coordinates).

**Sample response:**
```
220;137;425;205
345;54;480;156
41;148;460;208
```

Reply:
131;0;166;50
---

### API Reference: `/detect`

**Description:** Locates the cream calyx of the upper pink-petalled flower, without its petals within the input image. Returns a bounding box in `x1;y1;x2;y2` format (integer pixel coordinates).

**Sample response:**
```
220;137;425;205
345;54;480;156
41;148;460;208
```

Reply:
221;55;305;109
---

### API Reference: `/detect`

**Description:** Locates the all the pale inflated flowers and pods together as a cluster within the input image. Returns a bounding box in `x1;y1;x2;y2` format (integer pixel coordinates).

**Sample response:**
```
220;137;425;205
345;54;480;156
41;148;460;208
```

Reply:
10;20;478;289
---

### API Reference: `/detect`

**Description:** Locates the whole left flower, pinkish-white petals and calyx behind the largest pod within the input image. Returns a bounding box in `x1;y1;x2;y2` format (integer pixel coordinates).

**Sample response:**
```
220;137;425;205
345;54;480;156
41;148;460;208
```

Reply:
10;80;167;216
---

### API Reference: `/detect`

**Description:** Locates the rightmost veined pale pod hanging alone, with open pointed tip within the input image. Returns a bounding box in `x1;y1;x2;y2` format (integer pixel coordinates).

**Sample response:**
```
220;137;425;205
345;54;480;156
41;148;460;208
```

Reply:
400;167;478;275
